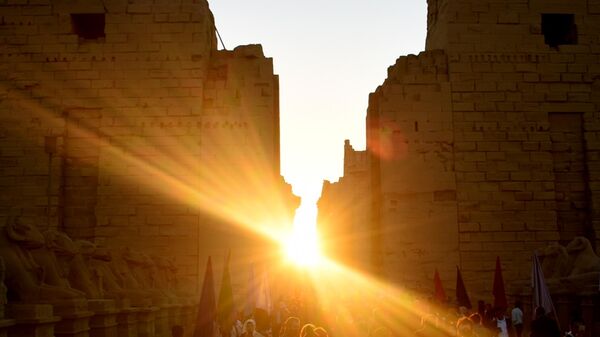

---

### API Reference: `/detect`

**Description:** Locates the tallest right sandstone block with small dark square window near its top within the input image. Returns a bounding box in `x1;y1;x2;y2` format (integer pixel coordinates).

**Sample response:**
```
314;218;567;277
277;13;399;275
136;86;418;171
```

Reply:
428;1;600;293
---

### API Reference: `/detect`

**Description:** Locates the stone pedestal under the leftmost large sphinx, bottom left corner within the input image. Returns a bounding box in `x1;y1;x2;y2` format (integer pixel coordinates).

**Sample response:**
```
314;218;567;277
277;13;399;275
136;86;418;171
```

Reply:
7;303;60;337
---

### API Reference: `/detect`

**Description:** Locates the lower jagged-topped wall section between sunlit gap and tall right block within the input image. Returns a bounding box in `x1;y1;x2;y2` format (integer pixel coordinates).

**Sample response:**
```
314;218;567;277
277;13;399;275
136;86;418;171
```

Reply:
367;51;458;291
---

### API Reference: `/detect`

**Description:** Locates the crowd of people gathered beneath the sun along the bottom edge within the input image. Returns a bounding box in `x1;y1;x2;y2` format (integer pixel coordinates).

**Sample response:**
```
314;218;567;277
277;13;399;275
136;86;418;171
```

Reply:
205;301;583;337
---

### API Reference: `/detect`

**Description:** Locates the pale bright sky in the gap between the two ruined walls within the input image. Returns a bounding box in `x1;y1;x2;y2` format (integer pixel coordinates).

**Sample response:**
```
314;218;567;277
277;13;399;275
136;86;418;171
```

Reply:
209;0;426;220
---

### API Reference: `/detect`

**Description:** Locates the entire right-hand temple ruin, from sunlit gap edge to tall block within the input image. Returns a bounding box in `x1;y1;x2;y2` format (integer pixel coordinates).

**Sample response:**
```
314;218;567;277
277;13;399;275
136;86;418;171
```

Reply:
319;0;600;300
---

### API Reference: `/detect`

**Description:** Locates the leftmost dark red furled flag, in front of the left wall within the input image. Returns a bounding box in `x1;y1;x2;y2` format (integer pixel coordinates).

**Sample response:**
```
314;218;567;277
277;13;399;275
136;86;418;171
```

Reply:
194;256;217;337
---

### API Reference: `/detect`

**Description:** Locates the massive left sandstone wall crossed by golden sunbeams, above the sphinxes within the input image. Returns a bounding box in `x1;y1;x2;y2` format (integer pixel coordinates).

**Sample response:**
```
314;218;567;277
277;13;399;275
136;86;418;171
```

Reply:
0;0;297;292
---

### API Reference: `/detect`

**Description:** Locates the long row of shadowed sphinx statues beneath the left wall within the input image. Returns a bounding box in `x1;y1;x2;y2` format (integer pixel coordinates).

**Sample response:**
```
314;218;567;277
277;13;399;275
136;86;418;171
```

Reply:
0;218;190;318
